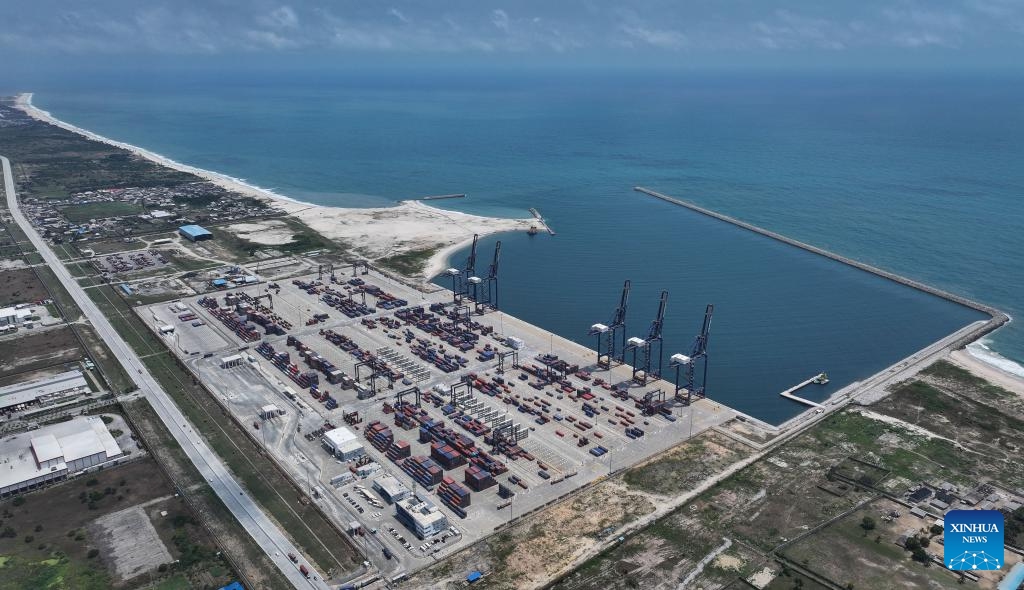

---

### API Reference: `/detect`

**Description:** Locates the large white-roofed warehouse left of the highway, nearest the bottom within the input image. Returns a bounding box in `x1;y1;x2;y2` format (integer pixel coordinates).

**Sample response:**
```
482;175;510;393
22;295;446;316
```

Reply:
0;416;124;497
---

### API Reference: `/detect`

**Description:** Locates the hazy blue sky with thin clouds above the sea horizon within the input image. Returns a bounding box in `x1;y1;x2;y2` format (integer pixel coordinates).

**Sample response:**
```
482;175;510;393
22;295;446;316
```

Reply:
0;0;1024;73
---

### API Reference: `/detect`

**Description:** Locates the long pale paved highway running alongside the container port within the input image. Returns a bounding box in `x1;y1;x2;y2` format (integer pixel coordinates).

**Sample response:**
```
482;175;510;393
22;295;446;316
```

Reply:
0;156;330;590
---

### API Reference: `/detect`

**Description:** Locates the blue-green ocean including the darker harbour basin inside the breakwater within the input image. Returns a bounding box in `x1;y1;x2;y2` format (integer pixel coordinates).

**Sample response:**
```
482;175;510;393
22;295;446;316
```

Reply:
18;70;1024;422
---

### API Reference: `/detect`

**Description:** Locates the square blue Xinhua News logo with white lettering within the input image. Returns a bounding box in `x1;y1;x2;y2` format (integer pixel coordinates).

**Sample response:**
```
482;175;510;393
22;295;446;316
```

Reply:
943;510;1004;571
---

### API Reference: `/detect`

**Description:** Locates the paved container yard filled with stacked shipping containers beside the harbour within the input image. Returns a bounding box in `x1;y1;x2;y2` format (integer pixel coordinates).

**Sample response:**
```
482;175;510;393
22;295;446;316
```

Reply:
136;265;736;572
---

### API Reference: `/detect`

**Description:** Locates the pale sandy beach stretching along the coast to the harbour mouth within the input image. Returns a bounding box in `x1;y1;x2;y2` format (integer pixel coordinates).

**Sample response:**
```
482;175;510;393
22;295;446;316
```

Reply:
15;93;536;279
